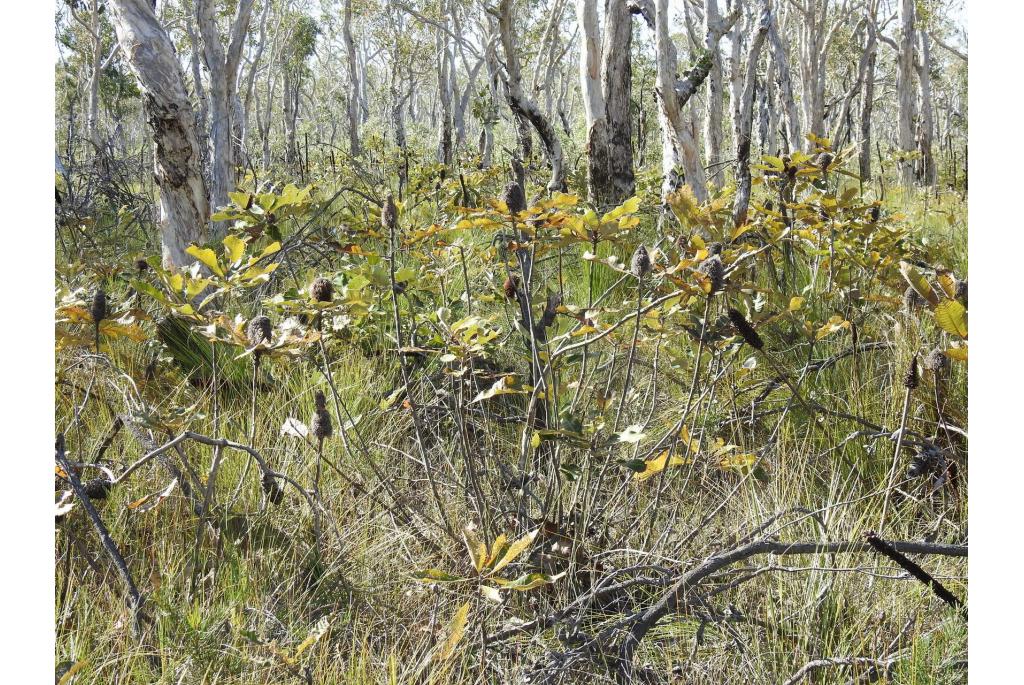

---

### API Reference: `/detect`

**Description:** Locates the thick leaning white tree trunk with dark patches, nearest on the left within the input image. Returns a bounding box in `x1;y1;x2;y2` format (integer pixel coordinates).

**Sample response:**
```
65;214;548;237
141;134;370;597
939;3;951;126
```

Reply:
112;0;210;268
